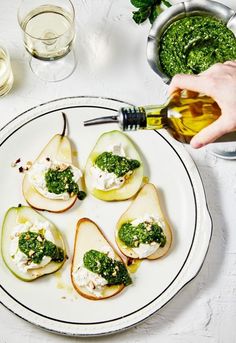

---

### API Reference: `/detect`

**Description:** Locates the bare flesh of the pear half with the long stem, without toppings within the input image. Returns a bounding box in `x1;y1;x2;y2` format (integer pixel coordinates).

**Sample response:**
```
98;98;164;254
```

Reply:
22;134;77;212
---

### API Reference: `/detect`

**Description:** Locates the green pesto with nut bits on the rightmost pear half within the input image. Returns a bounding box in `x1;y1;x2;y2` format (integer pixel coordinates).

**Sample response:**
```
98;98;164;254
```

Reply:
118;222;166;248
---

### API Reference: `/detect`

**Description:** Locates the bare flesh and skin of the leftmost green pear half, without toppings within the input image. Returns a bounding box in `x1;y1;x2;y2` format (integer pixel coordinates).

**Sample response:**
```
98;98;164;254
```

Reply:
1;206;65;281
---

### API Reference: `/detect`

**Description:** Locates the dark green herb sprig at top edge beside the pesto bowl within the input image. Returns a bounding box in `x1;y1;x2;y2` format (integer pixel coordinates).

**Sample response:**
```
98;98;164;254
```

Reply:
130;0;171;24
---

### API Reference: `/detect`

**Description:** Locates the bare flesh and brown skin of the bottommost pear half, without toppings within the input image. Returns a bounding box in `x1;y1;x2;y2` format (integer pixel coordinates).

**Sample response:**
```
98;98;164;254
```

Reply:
71;218;129;300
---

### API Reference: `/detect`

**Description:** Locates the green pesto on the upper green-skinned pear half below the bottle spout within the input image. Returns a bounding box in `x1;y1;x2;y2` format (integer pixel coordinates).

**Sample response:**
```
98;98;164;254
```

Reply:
95;151;140;177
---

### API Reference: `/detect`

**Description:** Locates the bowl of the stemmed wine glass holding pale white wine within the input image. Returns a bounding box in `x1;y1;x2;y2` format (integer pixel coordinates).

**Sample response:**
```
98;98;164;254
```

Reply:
21;5;75;61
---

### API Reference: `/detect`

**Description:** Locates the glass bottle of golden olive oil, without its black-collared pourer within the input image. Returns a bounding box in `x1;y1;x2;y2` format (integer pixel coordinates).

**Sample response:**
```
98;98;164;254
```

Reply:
142;90;221;143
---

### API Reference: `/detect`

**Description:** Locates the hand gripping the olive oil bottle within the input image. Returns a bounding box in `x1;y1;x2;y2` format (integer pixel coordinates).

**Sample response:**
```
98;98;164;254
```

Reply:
169;61;236;148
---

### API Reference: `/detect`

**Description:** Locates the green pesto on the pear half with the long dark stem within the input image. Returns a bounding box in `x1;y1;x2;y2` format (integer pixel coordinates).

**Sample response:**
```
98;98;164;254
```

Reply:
45;166;84;196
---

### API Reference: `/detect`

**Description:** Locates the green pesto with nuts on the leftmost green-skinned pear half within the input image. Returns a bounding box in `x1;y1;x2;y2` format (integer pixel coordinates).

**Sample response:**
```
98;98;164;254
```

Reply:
18;230;65;264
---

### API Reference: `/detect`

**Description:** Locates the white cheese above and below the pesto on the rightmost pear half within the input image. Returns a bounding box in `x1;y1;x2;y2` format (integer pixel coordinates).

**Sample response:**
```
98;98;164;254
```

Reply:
131;213;165;258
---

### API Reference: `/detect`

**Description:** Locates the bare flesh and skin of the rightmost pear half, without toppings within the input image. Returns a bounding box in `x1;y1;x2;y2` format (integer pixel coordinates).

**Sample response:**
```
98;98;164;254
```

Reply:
115;183;172;260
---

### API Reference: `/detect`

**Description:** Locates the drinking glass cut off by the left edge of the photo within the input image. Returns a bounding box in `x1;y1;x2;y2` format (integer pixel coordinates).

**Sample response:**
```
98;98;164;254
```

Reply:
0;43;13;96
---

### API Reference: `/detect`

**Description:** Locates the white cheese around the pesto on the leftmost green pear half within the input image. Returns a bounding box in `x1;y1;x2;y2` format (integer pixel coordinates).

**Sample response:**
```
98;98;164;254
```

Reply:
10;221;55;274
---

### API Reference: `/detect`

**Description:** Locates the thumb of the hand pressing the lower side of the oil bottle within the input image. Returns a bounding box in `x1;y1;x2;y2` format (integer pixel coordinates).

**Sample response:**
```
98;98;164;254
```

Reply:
190;117;229;148
